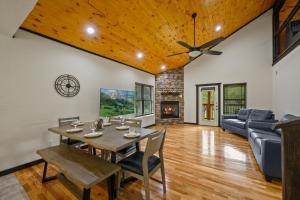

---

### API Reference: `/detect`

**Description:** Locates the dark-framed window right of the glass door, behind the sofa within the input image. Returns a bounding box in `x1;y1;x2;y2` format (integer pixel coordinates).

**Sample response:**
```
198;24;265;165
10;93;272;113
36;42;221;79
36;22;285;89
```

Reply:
223;83;246;114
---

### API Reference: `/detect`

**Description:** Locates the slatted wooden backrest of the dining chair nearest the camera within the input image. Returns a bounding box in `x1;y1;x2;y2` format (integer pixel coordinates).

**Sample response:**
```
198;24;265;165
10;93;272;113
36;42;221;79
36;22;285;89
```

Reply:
143;128;166;160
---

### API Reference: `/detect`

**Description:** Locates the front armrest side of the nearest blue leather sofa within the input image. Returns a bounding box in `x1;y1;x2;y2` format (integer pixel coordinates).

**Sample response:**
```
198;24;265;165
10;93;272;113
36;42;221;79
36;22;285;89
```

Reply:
261;139;281;178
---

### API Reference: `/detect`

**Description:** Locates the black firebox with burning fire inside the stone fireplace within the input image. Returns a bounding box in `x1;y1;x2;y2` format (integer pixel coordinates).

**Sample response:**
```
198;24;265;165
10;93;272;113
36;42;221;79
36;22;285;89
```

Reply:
160;101;179;119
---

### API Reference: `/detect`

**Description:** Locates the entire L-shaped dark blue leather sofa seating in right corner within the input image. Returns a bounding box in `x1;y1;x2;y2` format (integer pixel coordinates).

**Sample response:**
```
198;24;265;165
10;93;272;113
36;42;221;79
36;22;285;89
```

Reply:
221;109;298;181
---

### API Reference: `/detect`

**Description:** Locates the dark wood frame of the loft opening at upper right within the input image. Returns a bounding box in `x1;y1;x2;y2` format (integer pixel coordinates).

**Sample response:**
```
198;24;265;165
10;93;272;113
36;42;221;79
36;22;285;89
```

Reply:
272;0;300;66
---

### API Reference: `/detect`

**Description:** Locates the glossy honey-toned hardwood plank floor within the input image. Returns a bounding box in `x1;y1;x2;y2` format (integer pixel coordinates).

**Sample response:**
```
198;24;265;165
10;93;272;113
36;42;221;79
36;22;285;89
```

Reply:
16;125;281;200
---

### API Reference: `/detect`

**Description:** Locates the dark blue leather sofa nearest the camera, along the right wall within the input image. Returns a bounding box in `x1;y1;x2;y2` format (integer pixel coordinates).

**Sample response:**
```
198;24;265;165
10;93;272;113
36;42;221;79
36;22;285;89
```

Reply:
248;114;298;181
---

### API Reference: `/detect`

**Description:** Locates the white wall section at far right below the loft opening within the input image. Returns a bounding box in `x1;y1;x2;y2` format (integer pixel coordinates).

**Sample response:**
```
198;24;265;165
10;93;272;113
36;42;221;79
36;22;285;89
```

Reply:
273;46;300;118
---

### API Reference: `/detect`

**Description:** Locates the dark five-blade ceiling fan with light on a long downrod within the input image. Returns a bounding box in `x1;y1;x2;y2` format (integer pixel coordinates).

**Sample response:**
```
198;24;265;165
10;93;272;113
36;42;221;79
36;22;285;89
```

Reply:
168;13;225;62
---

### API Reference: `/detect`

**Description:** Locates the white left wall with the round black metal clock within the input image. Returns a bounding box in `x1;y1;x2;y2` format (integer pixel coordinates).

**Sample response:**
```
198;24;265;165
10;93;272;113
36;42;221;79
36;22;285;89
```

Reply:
0;31;155;171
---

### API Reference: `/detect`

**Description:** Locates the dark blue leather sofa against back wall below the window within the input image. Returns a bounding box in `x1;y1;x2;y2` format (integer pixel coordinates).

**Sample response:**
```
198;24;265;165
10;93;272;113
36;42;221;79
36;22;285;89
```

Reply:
221;109;274;137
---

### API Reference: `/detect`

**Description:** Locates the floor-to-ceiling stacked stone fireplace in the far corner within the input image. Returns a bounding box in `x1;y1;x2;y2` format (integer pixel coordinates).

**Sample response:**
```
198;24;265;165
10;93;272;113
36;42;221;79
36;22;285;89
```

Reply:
155;69;184;125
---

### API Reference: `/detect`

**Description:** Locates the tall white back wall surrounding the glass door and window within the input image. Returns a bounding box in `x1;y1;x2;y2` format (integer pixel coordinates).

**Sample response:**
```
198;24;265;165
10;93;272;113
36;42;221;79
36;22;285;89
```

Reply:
184;11;272;123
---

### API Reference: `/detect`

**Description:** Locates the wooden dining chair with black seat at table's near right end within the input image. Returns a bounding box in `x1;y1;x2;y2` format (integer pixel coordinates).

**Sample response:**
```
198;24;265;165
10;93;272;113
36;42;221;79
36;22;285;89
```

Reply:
118;129;166;200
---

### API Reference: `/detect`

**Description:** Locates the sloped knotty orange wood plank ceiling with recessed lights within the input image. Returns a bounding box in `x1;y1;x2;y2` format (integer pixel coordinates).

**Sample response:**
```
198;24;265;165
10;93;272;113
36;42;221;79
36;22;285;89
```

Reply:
21;0;275;74
